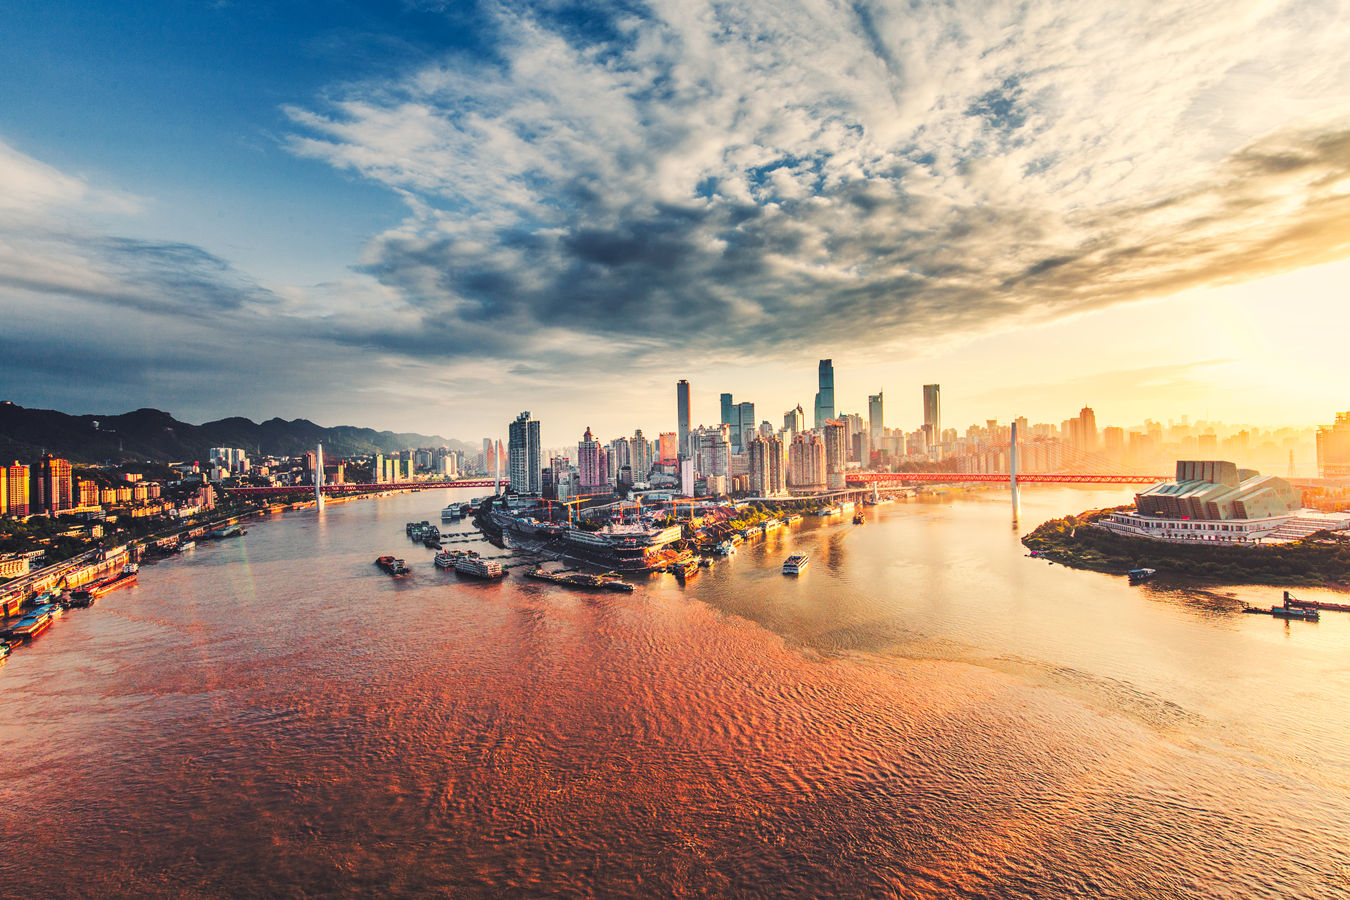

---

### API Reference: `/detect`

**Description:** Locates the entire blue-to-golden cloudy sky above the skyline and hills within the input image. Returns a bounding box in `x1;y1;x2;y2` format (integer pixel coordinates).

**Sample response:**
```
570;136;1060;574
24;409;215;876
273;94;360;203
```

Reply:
0;0;1350;445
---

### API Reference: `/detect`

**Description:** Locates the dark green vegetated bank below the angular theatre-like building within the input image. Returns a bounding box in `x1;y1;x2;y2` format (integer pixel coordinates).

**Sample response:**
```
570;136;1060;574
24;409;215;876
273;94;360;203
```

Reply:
1022;507;1350;590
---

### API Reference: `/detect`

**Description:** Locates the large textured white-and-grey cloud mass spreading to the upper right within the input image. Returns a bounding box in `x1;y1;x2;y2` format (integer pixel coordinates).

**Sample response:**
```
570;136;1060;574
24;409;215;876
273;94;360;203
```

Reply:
279;0;1350;367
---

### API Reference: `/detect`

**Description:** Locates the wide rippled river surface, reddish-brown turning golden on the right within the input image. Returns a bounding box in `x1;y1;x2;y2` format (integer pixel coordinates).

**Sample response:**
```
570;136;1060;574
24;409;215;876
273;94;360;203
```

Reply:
0;488;1350;897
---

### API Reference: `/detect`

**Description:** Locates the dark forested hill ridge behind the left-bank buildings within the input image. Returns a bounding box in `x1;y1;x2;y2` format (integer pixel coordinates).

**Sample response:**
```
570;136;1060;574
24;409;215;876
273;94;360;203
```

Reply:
0;403;478;463
